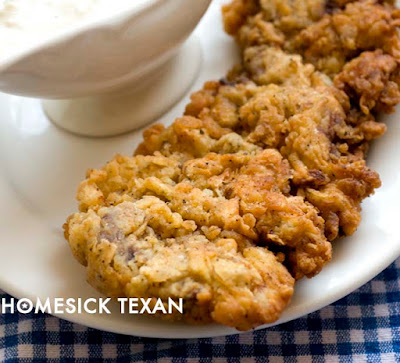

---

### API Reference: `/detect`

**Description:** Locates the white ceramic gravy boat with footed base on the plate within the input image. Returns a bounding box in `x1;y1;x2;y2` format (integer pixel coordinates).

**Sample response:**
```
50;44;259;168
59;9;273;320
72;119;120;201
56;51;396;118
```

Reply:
0;0;211;136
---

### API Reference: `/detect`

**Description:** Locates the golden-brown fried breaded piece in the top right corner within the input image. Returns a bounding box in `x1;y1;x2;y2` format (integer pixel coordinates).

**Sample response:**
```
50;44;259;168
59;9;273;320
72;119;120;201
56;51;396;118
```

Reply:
286;0;400;76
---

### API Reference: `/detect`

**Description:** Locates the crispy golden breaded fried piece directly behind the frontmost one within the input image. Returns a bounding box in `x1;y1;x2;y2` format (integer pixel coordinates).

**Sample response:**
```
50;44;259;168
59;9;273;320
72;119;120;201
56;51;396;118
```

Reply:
71;145;331;278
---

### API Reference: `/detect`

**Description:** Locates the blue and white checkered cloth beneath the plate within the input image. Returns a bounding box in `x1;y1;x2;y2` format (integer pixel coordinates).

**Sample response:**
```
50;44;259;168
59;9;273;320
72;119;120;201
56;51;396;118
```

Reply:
0;259;400;363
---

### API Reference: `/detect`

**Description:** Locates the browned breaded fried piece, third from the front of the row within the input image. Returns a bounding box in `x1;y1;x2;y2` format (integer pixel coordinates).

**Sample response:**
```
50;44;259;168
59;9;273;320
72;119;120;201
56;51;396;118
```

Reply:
181;78;385;240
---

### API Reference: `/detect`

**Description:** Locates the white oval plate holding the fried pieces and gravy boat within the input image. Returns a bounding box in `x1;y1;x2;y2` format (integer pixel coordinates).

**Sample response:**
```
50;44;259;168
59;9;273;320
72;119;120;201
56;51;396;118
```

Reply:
0;1;400;338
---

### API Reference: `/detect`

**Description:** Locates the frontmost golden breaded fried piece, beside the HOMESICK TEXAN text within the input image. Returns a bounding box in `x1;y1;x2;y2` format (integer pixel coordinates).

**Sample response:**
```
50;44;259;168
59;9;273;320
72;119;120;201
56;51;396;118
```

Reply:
66;200;294;330
